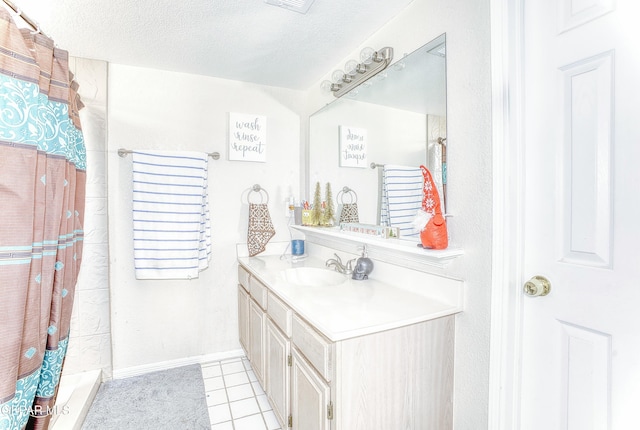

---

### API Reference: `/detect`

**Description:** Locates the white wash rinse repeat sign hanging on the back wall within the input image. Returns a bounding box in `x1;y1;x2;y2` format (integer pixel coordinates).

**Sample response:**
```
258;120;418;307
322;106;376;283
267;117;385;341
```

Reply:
229;112;267;163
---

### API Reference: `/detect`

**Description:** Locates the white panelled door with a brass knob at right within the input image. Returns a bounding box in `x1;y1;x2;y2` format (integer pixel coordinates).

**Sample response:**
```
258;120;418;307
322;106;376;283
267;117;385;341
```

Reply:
520;0;640;430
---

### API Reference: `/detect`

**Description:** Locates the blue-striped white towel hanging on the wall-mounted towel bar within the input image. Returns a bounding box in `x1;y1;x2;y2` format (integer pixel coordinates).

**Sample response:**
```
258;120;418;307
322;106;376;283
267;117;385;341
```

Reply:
133;151;211;279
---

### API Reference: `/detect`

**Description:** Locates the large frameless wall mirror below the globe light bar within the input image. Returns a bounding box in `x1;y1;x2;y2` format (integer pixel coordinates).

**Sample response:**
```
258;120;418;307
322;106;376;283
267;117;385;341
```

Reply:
308;34;447;237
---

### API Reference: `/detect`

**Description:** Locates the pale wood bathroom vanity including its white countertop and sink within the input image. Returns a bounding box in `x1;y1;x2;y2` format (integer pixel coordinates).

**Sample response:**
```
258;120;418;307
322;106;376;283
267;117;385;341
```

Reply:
238;255;462;430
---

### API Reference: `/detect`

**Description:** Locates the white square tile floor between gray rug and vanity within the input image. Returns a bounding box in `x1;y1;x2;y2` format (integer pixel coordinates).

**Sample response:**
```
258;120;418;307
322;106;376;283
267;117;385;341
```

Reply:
202;357;280;430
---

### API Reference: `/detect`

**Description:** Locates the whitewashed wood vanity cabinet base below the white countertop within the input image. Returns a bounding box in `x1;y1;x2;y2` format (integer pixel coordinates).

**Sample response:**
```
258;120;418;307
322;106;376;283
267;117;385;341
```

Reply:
238;260;455;430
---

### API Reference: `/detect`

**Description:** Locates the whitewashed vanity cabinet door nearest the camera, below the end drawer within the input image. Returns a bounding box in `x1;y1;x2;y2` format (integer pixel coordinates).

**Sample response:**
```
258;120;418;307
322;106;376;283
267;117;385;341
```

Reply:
291;348;333;430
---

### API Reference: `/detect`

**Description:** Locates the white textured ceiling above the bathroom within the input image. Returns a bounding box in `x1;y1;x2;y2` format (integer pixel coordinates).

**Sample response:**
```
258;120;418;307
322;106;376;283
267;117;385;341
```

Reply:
8;0;413;89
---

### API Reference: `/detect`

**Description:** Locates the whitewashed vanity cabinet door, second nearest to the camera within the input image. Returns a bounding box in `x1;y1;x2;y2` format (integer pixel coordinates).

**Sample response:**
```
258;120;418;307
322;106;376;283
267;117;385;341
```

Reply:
264;318;291;428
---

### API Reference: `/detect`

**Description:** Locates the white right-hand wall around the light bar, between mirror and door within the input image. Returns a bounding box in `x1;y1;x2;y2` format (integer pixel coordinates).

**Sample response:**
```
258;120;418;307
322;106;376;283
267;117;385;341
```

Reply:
307;0;492;430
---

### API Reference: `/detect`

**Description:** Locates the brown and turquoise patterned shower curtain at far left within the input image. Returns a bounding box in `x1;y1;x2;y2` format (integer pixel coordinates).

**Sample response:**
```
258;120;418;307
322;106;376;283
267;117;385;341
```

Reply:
0;8;86;430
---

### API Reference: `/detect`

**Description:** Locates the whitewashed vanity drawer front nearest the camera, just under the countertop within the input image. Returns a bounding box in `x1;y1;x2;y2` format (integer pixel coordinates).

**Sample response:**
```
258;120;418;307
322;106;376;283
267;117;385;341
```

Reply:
291;315;334;382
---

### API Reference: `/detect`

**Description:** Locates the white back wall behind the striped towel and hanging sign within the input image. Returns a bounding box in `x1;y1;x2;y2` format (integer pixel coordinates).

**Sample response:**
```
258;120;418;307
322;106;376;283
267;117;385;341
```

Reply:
108;64;303;374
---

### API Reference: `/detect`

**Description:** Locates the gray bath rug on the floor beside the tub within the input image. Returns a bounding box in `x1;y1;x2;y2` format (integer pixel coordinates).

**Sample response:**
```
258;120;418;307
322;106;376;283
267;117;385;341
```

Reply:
82;364;211;430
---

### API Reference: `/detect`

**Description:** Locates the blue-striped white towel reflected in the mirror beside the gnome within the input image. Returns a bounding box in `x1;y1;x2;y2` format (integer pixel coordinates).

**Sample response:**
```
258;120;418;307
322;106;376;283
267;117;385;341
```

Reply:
380;164;424;237
